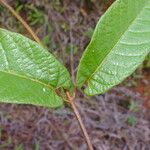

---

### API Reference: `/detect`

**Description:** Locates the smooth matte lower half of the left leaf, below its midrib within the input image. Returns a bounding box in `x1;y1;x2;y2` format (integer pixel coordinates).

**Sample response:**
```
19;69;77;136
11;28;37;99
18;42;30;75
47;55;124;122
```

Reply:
0;71;63;108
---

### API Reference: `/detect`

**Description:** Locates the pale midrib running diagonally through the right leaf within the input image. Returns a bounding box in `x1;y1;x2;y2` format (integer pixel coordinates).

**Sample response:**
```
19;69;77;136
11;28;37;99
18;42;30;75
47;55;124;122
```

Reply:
85;1;149;82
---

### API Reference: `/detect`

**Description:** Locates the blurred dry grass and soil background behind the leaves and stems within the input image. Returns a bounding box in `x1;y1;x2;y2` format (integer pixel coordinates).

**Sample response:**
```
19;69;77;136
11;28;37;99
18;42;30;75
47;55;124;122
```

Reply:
0;0;150;150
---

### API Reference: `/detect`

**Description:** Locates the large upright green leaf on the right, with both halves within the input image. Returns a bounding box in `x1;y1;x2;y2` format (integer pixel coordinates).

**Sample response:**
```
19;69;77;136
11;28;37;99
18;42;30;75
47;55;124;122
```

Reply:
77;0;150;95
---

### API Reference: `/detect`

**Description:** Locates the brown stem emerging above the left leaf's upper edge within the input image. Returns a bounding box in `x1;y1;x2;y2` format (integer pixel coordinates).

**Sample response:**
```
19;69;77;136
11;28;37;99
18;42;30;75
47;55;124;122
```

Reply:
0;0;42;45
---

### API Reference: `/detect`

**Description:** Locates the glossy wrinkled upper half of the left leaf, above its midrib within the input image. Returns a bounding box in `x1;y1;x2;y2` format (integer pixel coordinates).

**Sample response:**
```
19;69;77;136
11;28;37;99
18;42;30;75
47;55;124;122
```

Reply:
0;29;71;88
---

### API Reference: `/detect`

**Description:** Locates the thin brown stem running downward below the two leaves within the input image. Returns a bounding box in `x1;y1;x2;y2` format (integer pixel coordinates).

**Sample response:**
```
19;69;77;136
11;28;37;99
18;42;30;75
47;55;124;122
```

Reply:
66;92;94;150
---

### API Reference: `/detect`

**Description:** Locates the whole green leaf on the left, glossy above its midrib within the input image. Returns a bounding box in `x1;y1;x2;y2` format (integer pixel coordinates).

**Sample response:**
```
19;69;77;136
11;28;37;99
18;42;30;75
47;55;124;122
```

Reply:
0;29;71;107
